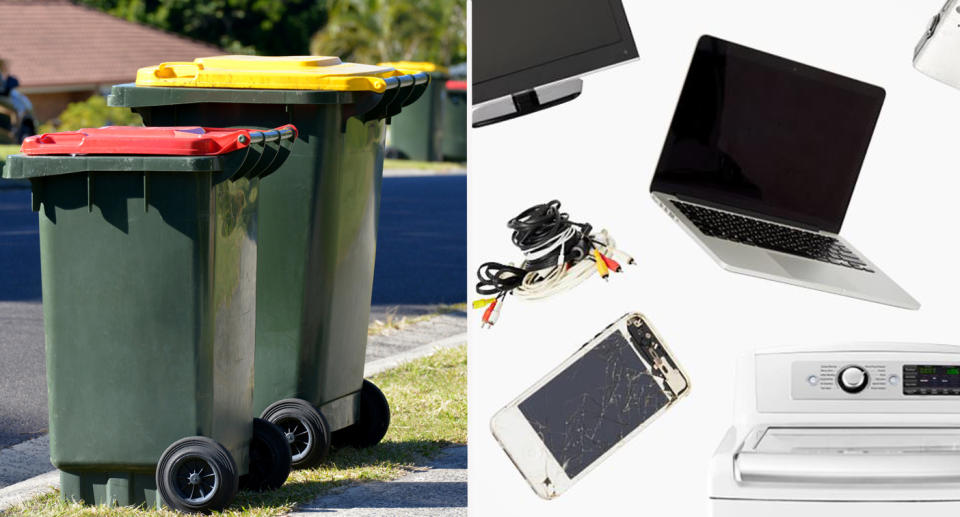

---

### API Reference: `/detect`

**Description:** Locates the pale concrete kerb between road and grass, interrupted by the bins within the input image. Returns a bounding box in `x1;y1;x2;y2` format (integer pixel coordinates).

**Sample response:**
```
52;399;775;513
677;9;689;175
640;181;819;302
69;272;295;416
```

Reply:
0;333;467;513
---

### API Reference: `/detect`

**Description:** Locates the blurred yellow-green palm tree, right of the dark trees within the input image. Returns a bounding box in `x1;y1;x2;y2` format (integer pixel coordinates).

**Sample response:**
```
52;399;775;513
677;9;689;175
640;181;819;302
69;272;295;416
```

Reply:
310;0;467;66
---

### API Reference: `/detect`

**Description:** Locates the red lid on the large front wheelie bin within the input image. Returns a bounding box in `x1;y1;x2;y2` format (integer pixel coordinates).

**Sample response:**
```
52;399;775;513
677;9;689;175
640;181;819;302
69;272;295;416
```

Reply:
20;125;296;156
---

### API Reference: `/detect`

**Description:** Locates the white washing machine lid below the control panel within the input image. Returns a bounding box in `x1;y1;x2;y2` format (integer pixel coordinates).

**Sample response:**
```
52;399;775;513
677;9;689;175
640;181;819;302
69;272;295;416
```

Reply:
734;427;960;486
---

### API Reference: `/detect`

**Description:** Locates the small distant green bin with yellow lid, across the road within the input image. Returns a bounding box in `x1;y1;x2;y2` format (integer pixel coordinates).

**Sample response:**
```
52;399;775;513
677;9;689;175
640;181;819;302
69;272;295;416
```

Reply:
381;61;447;162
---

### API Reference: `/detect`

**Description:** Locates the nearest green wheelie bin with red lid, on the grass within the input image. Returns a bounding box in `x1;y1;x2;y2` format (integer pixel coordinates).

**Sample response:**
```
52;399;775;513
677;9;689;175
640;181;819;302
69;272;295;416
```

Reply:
3;126;296;512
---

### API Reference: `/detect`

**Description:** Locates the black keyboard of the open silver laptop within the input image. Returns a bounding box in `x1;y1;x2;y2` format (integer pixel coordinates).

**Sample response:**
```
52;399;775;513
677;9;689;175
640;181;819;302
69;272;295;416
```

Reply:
671;200;873;273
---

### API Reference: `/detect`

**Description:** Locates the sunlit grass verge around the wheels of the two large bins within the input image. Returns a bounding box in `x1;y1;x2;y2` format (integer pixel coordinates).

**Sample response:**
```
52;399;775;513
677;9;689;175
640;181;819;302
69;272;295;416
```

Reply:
2;347;467;517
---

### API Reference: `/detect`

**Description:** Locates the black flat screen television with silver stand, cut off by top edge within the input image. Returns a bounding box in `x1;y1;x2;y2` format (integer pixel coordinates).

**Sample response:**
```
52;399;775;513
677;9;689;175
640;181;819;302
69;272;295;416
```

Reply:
471;0;638;127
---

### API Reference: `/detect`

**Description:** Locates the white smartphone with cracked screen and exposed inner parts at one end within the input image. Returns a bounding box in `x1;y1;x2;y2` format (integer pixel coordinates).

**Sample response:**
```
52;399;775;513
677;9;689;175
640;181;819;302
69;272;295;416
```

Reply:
490;313;690;499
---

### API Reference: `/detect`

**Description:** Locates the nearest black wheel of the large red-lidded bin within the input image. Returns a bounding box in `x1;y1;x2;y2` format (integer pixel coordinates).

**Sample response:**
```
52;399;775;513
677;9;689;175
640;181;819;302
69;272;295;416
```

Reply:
156;436;239;513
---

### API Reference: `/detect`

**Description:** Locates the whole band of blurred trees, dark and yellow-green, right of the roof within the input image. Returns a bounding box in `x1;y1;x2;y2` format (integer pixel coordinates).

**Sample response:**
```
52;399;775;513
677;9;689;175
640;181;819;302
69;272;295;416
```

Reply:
79;0;467;66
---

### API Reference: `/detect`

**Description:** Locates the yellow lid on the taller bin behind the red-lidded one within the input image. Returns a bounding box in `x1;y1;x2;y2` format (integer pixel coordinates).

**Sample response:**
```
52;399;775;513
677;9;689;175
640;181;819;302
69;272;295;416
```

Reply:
136;56;403;93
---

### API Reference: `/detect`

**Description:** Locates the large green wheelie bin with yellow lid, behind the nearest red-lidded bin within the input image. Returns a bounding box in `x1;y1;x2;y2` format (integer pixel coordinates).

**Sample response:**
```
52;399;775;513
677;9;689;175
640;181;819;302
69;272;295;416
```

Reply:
108;56;430;468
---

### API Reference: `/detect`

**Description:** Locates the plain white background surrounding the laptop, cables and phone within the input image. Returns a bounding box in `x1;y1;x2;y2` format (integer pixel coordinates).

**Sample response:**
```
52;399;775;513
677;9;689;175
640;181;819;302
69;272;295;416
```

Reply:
468;0;960;517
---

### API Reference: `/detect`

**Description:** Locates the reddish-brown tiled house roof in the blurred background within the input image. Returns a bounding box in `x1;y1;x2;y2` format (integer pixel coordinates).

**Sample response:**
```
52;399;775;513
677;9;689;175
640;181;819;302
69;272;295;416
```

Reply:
0;0;223;92
